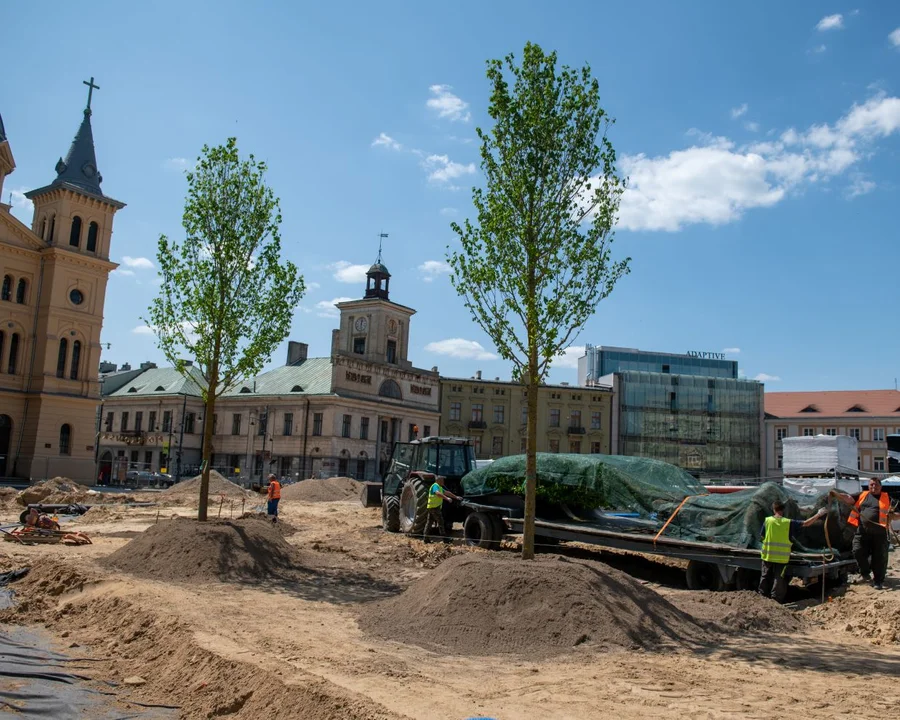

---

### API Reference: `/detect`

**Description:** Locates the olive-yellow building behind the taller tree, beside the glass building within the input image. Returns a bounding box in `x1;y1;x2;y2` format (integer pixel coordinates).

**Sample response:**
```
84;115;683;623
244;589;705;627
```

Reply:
441;370;613;459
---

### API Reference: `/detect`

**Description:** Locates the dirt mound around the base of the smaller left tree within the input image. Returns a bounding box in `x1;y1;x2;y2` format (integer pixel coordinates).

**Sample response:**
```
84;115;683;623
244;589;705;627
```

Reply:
101;518;301;582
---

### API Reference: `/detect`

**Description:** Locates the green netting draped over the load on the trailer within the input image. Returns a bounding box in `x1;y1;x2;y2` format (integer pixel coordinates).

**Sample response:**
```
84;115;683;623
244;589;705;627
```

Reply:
462;453;852;552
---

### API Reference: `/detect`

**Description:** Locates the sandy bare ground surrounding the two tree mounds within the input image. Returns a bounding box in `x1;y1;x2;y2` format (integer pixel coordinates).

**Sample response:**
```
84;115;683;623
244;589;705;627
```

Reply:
0;501;900;720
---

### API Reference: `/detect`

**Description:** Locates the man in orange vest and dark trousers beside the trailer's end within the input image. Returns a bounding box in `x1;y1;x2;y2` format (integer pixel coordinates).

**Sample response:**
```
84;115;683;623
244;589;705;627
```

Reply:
829;478;891;590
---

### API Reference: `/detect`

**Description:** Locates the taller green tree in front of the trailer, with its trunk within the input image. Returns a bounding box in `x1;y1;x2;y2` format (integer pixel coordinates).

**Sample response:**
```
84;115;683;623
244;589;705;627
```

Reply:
448;43;630;559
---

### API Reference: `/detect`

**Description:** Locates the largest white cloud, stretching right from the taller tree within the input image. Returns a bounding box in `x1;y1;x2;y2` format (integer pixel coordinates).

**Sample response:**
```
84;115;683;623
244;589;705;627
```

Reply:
619;93;900;231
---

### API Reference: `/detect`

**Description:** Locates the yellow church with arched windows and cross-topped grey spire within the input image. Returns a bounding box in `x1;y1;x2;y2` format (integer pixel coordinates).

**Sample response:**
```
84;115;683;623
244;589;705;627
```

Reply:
0;80;124;482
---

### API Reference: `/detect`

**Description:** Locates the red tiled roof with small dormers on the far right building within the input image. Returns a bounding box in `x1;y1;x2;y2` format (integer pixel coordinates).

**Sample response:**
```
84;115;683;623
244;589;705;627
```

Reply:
765;390;900;418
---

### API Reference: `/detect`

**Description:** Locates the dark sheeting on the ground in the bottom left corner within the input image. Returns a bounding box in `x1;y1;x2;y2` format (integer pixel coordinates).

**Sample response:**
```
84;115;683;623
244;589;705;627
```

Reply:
0;625;178;720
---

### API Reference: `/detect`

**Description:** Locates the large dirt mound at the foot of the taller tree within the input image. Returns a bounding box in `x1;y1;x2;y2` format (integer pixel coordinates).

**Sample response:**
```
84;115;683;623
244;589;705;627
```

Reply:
359;553;709;658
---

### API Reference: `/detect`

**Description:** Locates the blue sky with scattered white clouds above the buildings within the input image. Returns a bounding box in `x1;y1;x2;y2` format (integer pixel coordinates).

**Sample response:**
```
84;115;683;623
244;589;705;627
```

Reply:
0;0;900;391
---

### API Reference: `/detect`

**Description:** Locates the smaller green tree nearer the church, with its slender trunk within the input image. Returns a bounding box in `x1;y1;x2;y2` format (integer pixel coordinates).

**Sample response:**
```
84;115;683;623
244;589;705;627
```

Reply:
148;138;305;520
